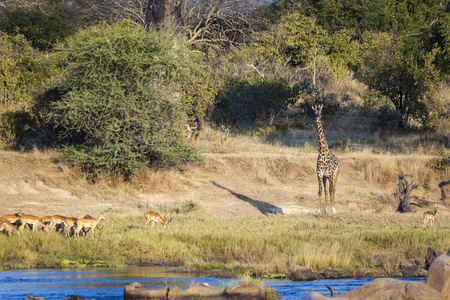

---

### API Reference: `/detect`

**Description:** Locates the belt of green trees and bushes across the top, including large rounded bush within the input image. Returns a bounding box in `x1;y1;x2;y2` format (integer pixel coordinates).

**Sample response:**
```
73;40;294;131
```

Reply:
0;0;450;177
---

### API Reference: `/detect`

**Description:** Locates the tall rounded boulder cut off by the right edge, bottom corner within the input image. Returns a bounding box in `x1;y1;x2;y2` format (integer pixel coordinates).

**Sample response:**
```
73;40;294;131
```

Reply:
425;255;450;298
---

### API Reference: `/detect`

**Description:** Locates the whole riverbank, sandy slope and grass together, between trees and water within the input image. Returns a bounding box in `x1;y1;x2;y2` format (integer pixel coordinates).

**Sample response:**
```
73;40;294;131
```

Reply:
0;133;450;278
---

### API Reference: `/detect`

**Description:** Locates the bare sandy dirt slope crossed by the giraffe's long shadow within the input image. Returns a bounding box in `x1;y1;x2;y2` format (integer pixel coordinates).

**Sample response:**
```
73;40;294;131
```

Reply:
0;144;441;222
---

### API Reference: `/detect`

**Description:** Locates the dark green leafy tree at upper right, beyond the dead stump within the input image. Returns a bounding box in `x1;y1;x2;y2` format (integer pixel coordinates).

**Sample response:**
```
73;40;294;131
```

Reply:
357;32;439;128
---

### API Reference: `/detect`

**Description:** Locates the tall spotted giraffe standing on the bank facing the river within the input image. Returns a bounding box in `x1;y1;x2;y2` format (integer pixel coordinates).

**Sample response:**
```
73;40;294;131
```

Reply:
313;104;339;215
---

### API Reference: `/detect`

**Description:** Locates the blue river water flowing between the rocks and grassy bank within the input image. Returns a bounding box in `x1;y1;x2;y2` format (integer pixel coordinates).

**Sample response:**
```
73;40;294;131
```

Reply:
0;267;424;300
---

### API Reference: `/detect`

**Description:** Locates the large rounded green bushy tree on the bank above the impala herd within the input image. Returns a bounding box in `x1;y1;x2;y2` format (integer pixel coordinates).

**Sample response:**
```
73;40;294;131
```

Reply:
35;22;207;178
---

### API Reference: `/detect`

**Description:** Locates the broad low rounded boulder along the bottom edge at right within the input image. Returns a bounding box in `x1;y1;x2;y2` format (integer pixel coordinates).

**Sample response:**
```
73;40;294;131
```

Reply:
333;278;445;300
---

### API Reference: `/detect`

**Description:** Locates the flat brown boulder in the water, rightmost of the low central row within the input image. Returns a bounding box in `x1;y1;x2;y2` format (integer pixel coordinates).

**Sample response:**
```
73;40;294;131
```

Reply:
223;285;281;300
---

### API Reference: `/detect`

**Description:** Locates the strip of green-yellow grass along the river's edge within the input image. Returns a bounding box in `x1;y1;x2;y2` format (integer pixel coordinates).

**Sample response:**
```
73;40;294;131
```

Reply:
0;211;450;278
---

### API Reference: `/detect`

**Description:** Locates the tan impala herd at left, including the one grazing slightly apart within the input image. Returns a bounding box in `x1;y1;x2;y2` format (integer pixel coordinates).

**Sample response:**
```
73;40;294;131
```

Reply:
0;211;172;237
